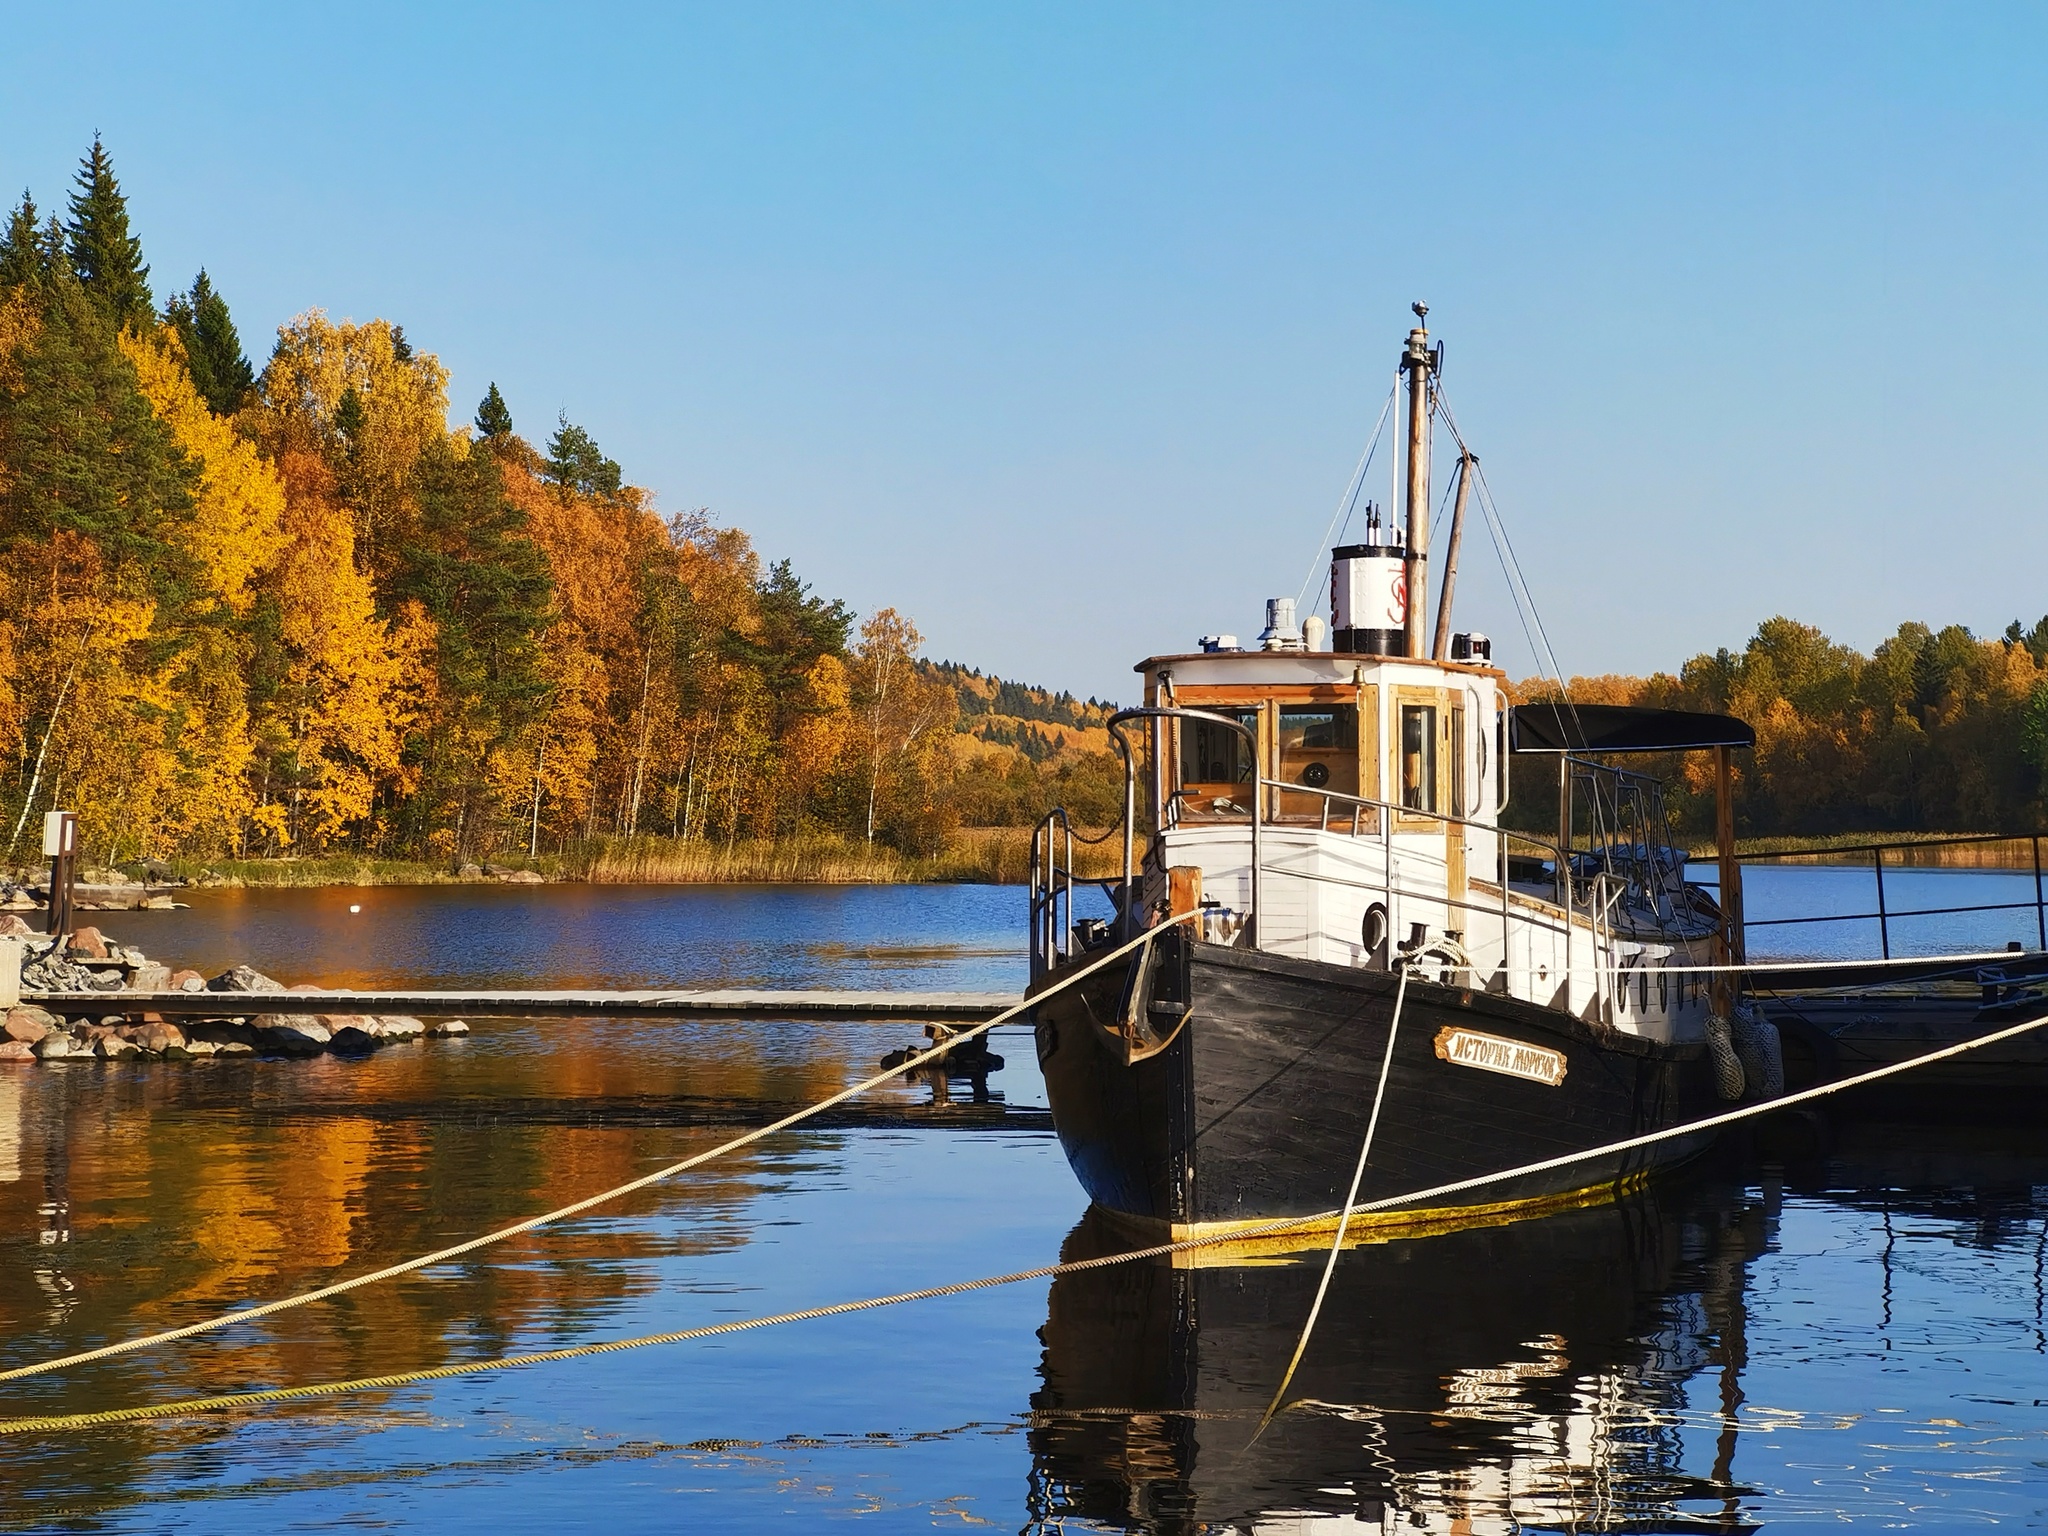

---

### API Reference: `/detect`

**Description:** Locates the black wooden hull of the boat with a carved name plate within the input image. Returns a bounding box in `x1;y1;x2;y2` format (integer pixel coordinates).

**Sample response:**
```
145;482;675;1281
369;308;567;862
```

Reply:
1032;932;1716;1239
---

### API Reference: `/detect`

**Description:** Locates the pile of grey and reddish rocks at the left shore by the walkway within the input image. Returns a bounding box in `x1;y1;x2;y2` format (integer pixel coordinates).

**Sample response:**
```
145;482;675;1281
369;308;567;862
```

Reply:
0;913;469;1061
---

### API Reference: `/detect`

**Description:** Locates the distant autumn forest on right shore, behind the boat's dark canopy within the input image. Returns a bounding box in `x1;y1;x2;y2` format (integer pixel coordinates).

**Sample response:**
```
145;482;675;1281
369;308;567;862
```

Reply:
1509;616;2048;836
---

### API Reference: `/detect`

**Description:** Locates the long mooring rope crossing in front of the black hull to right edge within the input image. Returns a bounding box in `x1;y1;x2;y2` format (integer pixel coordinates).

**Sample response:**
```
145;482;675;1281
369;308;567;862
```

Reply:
16;999;2048;1436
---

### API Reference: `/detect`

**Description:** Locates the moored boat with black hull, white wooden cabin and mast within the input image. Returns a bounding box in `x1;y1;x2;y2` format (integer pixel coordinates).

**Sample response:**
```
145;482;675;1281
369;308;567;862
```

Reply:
1028;305;1757;1245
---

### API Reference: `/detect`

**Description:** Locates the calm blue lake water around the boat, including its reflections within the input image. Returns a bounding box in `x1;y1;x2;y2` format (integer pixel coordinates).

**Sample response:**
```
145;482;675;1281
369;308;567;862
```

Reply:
0;870;2048;1532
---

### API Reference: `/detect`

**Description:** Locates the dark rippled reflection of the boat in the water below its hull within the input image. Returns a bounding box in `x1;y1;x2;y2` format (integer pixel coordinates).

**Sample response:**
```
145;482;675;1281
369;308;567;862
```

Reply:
1032;1184;1769;1532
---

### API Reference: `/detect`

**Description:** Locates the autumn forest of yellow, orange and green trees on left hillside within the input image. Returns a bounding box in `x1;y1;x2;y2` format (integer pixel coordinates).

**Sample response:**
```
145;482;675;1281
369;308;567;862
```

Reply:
0;141;1116;862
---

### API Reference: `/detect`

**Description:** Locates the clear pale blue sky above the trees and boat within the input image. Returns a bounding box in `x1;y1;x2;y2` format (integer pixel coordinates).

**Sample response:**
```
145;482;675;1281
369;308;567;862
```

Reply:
0;4;2048;696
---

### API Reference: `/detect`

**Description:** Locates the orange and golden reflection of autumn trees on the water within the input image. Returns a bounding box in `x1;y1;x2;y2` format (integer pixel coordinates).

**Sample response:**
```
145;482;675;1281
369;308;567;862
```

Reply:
0;1020;1024;1524
